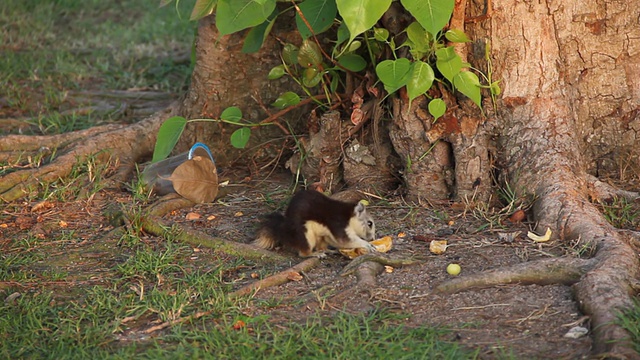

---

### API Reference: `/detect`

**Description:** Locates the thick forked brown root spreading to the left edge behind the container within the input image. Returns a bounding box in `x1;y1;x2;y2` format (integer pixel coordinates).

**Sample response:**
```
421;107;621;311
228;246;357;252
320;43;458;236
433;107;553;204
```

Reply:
0;103;179;202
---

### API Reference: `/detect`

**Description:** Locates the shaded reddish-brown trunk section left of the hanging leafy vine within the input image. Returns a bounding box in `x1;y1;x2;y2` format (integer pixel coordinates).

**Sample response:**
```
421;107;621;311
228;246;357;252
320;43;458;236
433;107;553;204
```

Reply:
171;12;308;166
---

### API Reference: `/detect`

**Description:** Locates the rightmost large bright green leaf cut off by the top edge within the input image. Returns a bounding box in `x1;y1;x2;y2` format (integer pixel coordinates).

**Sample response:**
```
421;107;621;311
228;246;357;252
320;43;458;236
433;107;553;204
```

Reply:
402;0;455;38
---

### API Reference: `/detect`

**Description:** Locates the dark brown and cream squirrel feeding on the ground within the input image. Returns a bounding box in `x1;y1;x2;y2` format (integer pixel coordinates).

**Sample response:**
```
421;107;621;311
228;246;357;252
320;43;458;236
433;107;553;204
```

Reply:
253;190;376;257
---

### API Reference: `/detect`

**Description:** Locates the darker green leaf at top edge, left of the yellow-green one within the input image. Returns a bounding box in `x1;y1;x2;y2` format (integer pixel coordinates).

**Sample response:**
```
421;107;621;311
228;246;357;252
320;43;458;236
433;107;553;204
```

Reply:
296;0;338;39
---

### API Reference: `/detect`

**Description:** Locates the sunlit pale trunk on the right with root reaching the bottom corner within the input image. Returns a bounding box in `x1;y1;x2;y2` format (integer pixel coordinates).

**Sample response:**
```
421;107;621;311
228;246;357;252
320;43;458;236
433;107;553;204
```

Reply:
460;1;640;357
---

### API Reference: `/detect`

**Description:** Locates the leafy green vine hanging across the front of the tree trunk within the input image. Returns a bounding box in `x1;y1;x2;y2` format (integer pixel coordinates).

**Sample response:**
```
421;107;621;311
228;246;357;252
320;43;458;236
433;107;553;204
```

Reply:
153;0;500;161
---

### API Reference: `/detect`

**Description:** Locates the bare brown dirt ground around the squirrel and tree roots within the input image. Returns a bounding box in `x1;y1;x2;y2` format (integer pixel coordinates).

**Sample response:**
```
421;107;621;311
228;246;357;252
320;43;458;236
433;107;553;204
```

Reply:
0;171;591;359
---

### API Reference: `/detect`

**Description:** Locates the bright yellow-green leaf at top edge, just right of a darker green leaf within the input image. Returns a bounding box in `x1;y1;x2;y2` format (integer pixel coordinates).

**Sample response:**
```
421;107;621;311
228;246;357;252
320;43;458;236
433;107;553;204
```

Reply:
336;0;391;42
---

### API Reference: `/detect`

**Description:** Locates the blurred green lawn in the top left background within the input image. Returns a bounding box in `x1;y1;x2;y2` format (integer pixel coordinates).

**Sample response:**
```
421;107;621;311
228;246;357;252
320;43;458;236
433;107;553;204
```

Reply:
0;0;196;122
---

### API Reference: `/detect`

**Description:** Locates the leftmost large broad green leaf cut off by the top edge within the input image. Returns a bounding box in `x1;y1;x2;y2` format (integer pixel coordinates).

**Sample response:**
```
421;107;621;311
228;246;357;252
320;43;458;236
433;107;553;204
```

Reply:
216;0;276;35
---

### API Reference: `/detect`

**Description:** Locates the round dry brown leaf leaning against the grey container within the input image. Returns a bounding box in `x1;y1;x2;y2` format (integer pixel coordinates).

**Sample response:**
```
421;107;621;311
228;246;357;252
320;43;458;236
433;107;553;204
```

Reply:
168;156;218;204
